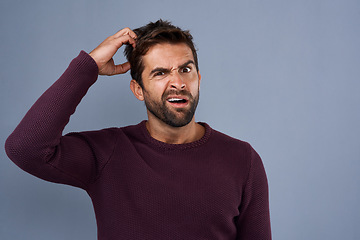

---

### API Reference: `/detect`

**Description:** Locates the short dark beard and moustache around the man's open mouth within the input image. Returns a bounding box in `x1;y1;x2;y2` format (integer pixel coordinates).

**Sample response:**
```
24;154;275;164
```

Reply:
144;87;199;127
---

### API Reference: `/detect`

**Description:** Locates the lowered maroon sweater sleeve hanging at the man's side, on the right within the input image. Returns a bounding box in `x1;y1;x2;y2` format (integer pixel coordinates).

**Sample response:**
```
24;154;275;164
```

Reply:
237;145;271;240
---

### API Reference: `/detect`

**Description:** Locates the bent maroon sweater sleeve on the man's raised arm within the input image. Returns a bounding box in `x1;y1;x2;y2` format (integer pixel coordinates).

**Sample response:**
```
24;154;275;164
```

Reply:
5;51;112;189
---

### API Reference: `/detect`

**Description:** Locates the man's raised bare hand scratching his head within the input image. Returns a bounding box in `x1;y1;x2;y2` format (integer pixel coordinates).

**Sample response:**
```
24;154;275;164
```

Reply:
89;28;137;76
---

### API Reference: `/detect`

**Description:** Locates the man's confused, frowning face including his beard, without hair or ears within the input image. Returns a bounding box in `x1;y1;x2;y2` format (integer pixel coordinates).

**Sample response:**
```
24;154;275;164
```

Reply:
142;43;200;127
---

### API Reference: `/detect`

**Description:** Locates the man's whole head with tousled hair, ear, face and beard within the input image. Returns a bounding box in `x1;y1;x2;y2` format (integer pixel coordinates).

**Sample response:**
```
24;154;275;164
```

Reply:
125;20;201;127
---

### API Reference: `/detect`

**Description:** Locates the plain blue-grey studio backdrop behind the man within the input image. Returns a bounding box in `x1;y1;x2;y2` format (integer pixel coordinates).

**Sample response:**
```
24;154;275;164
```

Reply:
0;0;360;240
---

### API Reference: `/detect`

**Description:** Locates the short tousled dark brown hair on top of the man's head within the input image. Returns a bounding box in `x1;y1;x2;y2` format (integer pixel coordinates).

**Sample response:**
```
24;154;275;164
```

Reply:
124;19;199;88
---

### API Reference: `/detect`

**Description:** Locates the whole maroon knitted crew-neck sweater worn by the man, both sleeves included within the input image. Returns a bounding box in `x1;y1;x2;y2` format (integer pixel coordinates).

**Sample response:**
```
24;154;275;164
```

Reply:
6;51;271;240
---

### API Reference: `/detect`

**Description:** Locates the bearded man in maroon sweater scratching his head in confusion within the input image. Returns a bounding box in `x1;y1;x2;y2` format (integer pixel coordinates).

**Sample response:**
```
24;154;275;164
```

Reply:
6;20;271;240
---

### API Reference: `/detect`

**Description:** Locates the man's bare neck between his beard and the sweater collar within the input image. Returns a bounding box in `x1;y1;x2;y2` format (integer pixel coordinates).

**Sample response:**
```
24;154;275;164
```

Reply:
146;116;205;144
